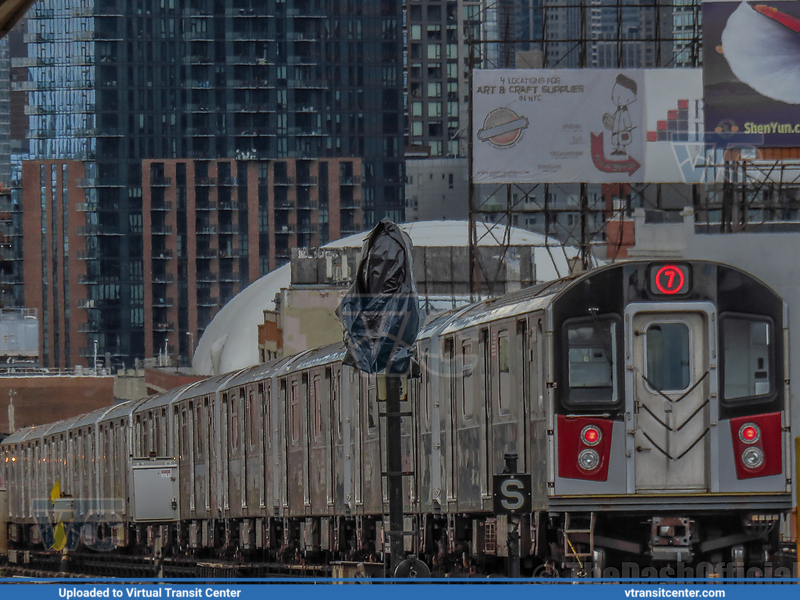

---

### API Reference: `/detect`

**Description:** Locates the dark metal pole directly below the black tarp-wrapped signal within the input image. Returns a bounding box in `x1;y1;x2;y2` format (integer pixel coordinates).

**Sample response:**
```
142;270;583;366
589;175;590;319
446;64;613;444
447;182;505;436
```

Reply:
386;375;404;575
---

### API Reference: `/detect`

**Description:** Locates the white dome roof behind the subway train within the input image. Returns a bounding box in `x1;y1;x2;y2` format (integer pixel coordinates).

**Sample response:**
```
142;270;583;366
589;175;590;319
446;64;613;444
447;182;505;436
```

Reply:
192;221;579;375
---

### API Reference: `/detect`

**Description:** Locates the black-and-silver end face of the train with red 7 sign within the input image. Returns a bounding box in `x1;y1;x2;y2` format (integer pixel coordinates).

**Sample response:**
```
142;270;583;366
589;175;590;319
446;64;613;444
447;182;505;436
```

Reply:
548;261;792;576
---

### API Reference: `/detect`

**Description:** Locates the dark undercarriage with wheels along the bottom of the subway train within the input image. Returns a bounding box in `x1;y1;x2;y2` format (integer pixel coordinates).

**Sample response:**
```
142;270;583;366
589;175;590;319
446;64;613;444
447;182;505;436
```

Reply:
8;511;793;579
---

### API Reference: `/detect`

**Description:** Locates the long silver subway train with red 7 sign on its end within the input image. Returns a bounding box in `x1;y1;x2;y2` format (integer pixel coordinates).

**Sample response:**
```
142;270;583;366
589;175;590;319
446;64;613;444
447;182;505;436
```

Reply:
0;261;792;576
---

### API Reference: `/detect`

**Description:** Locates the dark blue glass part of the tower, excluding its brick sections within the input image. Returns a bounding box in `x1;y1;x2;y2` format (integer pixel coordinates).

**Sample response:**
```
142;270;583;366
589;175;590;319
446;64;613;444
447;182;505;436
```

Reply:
17;0;405;364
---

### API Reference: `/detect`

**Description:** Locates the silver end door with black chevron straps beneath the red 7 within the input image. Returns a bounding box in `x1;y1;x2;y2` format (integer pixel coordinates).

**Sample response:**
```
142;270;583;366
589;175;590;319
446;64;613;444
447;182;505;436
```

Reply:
626;308;714;493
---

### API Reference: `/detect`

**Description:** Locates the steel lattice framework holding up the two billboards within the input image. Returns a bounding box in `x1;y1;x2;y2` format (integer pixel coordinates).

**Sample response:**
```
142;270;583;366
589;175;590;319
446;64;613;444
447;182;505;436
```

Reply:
467;0;800;300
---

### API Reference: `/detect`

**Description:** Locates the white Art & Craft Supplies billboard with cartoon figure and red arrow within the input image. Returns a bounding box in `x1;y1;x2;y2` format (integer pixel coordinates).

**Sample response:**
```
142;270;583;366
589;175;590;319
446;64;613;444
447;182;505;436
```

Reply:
472;69;715;183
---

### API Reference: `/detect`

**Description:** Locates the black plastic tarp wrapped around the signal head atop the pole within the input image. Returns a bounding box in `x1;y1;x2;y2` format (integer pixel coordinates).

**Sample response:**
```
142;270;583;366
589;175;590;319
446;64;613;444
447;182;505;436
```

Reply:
337;219;419;374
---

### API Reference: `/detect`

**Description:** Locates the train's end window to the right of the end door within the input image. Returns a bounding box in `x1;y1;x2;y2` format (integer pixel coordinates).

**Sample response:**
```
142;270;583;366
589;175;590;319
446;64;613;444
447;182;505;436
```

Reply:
720;315;775;401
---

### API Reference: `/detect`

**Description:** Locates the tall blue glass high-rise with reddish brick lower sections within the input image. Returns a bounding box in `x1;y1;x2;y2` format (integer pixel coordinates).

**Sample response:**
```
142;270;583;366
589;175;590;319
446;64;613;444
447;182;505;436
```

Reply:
16;0;404;366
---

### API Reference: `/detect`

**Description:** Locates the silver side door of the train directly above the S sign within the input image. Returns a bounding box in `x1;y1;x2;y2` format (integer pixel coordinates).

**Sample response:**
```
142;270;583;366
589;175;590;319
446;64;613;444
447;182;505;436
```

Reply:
490;322;525;474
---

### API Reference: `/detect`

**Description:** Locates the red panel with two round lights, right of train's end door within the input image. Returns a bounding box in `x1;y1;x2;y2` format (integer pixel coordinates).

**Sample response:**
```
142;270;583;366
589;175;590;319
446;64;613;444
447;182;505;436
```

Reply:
731;413;783;479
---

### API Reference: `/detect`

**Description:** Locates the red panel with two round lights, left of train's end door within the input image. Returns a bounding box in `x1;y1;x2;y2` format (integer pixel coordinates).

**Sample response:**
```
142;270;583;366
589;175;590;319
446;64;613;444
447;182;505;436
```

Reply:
558;415;613;481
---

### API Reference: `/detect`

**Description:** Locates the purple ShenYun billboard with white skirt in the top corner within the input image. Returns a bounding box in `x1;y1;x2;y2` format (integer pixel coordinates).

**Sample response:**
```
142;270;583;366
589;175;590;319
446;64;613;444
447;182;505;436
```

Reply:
703;0;800;147
